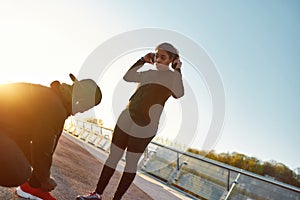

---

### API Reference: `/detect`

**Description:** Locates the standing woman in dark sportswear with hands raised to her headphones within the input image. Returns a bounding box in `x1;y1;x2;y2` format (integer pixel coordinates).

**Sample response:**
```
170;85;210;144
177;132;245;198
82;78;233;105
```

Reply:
77;43;184;200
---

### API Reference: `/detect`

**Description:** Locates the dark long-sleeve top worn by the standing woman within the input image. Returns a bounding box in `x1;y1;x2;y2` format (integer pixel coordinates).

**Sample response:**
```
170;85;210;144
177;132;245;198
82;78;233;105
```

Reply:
123;60;184;126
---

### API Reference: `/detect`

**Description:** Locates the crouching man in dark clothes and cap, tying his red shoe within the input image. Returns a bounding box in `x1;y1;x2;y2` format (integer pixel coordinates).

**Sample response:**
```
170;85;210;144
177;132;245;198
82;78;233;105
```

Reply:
0;74;102;200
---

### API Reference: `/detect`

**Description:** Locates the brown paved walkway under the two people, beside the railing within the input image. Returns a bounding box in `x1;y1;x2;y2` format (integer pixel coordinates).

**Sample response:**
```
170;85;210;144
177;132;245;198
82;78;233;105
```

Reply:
0;134;189;200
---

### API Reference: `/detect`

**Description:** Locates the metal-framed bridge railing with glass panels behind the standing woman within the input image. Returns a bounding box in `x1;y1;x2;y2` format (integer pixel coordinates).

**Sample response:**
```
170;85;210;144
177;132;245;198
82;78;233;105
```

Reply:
65;118;300;200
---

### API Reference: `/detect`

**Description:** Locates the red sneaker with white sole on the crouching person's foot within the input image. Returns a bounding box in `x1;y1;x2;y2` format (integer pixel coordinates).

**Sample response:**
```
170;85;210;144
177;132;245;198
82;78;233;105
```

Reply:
17;182;56;200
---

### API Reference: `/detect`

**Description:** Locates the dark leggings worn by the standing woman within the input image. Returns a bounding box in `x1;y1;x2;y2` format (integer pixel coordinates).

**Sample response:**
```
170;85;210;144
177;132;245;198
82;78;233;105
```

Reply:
95;125;154;200
